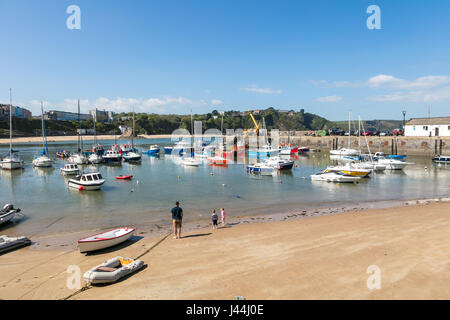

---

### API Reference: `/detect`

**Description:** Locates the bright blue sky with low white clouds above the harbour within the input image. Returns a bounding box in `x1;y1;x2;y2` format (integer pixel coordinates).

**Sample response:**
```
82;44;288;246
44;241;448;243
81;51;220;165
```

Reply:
0;0;450;120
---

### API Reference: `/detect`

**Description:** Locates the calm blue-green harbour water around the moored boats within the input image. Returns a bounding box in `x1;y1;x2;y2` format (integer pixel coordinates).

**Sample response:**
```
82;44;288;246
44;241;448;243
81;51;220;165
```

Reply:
0;139;450;235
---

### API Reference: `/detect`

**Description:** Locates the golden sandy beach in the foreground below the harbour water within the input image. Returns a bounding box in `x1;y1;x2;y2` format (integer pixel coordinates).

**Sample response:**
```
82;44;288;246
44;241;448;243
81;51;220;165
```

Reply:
0;202;450;299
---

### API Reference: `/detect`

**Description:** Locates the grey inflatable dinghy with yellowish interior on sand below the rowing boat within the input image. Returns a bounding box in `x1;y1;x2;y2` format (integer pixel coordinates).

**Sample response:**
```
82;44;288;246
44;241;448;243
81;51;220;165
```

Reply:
83;256;144;284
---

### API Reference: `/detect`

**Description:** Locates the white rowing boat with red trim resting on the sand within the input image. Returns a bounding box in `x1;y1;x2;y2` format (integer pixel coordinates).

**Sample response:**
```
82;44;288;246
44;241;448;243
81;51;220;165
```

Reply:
78;227;136;252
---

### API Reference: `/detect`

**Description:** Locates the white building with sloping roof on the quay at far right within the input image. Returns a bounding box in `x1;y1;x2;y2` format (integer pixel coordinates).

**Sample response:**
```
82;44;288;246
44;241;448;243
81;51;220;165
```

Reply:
405;117;450;137
